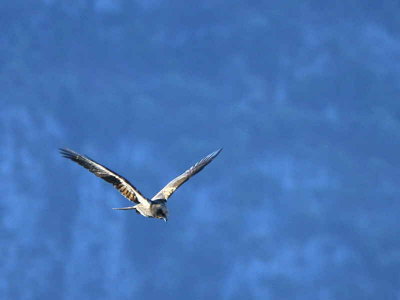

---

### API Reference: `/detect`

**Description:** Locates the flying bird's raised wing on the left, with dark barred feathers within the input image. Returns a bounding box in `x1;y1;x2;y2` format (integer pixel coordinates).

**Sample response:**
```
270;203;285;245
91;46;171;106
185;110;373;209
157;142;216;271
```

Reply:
59;149;149;204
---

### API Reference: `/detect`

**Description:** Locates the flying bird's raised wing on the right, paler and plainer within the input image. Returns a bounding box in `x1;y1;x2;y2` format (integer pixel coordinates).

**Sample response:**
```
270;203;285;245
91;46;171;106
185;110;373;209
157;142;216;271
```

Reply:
151;148;222;200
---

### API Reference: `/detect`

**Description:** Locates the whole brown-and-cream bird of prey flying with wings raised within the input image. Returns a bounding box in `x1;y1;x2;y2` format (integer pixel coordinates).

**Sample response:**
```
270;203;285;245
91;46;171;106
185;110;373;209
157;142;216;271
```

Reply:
59;148;222;222
